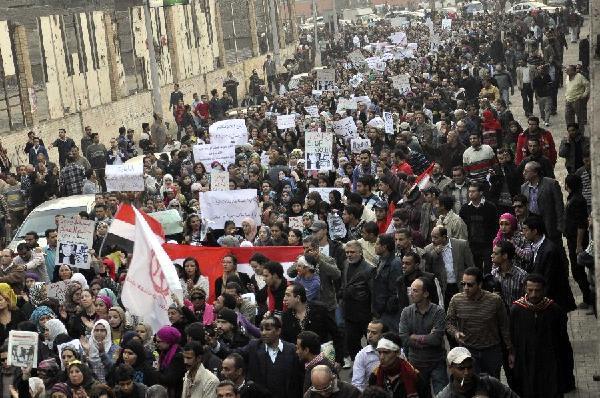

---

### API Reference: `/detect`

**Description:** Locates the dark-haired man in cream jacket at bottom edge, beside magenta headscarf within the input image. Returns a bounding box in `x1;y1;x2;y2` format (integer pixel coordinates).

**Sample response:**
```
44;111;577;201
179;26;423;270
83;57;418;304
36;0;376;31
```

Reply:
181;341;219;398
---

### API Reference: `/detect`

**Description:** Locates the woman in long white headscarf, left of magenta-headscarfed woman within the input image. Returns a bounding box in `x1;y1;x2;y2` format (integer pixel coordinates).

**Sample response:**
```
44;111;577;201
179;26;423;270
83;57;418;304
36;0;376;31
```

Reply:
83;319;119;383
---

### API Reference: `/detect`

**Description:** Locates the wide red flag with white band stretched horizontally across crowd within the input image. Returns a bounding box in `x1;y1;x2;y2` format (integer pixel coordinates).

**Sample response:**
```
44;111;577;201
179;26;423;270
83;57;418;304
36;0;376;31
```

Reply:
163;243;303;303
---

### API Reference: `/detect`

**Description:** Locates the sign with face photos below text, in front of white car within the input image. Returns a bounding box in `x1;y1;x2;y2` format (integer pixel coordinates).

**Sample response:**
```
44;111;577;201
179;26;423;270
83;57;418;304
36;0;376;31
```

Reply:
56;218;96;269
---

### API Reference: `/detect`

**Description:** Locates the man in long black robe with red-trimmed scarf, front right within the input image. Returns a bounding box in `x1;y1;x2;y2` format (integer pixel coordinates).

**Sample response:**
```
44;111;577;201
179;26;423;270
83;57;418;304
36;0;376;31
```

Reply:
510;274;575;398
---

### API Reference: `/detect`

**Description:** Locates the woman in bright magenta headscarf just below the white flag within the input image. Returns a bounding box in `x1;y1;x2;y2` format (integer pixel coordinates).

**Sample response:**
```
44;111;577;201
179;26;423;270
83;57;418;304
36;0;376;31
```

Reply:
156;326;186;398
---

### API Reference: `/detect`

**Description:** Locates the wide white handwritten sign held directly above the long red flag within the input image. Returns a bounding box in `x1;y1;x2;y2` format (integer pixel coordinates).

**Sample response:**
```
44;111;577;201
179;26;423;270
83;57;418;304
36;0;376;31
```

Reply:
200;189;261;229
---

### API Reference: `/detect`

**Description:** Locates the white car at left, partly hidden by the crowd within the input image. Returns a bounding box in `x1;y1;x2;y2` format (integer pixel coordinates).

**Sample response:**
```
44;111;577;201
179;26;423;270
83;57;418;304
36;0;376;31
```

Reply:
8;195;96;251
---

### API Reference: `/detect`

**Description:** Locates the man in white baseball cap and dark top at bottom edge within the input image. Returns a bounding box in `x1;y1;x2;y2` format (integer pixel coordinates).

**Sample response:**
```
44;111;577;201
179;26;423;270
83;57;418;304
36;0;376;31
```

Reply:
436;347;519;398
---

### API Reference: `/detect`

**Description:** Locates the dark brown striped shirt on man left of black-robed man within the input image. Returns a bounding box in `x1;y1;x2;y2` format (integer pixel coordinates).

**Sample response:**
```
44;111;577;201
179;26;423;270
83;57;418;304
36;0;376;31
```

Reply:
446;290;512;350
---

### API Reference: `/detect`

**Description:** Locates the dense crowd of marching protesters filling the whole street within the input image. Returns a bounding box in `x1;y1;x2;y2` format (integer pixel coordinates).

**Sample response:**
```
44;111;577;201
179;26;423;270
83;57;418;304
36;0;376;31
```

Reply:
0;2;596;398
